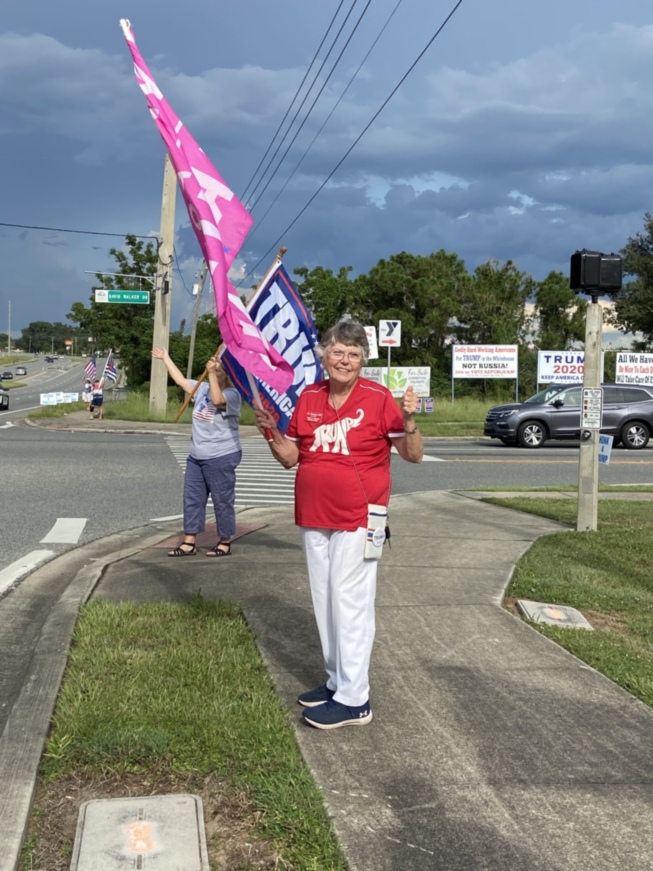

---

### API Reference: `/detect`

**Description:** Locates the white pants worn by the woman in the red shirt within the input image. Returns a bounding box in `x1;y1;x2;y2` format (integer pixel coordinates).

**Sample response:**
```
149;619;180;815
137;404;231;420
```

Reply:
301;527;378;706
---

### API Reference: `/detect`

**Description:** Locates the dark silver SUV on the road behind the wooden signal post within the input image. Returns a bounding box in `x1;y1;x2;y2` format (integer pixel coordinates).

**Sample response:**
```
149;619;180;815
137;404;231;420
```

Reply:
483;384;653;450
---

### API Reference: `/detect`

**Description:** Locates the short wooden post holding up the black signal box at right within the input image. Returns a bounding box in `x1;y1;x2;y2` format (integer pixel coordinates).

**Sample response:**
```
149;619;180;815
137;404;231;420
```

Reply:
576;297;603;532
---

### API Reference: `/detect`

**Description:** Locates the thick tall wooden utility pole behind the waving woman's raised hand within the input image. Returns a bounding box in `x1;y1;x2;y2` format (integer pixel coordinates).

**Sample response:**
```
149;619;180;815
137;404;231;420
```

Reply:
150;153;177;414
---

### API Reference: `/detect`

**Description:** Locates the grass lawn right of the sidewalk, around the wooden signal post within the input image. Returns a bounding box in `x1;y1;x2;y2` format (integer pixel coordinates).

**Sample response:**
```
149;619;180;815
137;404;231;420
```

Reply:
488;497;653;706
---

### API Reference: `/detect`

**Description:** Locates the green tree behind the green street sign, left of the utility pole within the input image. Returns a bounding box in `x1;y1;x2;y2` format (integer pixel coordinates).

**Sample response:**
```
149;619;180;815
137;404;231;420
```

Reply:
67;235;158;387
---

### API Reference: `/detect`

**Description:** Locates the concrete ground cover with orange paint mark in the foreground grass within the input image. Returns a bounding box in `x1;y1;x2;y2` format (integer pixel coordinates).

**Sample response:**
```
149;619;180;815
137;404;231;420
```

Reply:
70;795;209;871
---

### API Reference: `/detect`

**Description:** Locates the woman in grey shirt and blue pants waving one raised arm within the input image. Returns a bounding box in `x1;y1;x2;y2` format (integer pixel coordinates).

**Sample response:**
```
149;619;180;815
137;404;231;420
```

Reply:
152;348;242;557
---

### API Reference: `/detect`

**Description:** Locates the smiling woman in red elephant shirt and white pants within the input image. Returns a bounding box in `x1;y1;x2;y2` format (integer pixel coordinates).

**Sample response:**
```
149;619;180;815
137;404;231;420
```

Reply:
255;321;424;729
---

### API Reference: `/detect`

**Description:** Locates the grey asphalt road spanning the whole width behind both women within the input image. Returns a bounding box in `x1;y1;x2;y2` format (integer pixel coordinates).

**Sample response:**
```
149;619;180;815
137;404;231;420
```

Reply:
0;360;653;592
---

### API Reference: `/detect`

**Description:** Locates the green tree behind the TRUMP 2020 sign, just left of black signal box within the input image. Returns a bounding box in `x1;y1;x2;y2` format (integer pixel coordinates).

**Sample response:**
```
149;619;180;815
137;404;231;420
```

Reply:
534;272;587;351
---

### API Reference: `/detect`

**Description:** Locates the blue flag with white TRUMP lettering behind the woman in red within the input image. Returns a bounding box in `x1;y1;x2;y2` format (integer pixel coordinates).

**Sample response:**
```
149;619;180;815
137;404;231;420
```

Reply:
221;263;323;433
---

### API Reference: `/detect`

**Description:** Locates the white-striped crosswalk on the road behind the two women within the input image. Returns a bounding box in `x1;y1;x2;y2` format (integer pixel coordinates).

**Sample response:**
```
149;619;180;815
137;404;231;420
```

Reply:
166;436;295;507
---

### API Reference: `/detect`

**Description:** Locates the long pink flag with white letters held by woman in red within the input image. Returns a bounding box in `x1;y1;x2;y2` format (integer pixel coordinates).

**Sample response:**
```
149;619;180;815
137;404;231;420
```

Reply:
120;18;293;393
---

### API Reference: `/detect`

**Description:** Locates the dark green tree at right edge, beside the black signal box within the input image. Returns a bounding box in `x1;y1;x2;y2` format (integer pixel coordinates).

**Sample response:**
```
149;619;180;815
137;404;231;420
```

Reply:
611;212;653;351
